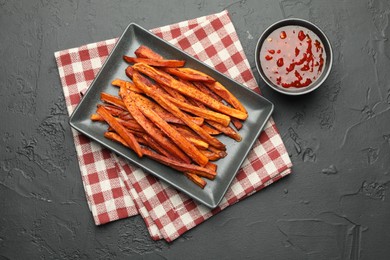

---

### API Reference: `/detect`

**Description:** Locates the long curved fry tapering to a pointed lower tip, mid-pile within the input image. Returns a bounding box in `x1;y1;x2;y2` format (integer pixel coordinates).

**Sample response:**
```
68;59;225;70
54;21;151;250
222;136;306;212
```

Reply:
119;88;191;163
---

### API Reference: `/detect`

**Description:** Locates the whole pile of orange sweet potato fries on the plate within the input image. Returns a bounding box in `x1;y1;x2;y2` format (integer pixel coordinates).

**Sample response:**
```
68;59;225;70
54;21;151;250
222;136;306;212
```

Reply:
91;46;248;189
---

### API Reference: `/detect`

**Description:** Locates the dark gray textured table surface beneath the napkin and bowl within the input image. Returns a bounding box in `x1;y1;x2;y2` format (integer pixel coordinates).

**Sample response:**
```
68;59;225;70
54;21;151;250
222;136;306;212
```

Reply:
0;0;390;259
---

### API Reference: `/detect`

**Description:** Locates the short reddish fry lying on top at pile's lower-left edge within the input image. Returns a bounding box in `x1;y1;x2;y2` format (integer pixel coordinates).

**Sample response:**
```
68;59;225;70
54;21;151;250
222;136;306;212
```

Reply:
96;106;143;157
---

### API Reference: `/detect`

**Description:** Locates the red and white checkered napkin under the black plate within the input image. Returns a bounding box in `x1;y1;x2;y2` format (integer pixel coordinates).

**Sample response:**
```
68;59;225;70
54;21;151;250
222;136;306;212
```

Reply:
55;11;291;241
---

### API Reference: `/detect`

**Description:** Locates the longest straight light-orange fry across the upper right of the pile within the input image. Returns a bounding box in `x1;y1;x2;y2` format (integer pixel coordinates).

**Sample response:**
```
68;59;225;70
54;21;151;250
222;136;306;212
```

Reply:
133;63;248;120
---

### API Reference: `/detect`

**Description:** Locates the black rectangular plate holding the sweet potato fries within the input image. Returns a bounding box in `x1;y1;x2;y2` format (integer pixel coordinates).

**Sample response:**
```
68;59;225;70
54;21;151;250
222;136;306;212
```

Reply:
70;23;273;208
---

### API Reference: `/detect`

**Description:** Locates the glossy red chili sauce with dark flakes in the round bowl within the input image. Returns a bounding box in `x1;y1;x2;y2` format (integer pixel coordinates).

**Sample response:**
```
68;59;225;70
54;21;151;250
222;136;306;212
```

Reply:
260;26;326;88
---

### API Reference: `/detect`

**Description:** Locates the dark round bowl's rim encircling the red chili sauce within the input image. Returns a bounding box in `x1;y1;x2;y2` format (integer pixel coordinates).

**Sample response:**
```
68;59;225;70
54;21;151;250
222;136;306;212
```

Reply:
255;17;333;96
